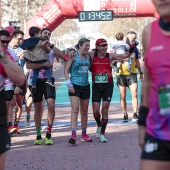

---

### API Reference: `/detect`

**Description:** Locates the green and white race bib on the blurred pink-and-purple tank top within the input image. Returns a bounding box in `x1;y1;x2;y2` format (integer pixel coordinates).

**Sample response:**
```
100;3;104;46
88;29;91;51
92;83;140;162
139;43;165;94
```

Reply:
158;85;170;115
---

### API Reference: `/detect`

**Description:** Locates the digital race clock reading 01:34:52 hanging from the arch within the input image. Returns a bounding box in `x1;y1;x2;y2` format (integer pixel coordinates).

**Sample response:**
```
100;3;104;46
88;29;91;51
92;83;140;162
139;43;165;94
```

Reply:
78;10;113;22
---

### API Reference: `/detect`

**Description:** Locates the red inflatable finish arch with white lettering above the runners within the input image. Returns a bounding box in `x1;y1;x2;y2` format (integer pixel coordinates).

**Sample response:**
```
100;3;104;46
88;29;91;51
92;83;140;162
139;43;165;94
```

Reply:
26;0;156;35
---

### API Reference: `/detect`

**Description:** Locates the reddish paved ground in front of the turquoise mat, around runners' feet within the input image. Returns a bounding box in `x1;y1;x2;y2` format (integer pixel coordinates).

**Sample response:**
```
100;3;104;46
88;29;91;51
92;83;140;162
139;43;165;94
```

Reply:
6;105;140;170
